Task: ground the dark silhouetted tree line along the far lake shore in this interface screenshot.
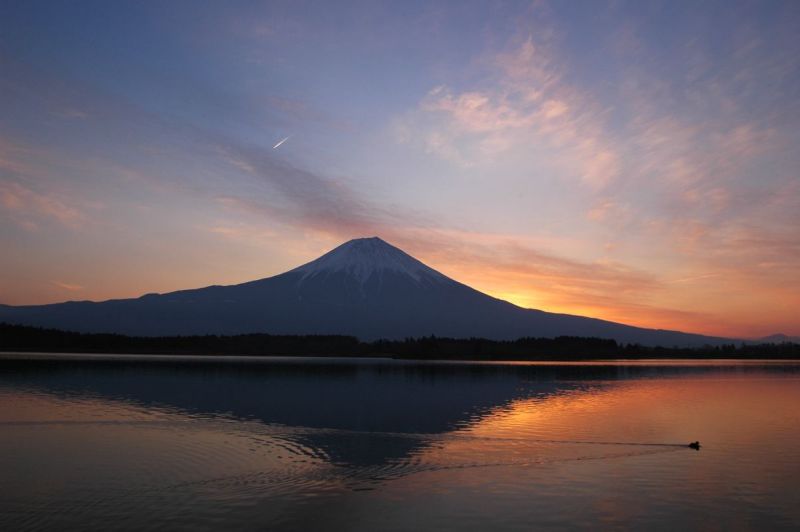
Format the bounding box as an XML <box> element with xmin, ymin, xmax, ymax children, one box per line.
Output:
<box><xmin>0</xmin><ymin>323</ymin><xmax>800</xmax><ymax>360</ymax></box>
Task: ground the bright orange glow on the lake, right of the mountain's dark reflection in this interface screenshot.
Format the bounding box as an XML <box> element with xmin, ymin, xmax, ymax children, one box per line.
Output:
<box><xmin>404</xmin><ymin>377</ymin><xmax>800</xmax><ymax>476</ymax></box>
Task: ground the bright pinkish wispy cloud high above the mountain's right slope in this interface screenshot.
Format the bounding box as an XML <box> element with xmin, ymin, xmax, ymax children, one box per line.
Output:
<box><xmin>402</xmin><ymin>32</ymin><xmax>621</xmax><ymax>189</ymax></box>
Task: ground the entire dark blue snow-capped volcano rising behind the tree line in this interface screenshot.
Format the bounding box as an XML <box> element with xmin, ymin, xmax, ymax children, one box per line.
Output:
<box><xmin>0</xmin><ymin>237</ymin><xmax>731</xmax><ymax>347</ymax></box>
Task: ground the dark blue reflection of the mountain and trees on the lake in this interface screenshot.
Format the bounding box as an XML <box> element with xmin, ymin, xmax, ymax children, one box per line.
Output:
<box><xmin>0</xmin><ymin>357</ymin><xmax>788</xmax><ymax>465</ymax></box>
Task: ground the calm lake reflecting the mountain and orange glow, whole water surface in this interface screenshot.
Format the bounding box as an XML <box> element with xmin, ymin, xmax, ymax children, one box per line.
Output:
<box><xmin>0</xmin><ymin>354</ymin><xmax>800</xmax><ymax>531</ymax></box>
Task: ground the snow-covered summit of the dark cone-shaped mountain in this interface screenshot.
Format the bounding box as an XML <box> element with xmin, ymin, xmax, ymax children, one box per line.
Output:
<box><xmin>292</xmin><ymin>236</ymin><xmax>448</xmax><ymax>284</ymax></box>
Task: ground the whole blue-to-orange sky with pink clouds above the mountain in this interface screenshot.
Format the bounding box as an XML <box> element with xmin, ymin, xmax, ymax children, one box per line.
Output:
<box><xmin>0</xmin><ymin>0</ymin><xmax>800</xmax><ymax>337</ymax></box>
